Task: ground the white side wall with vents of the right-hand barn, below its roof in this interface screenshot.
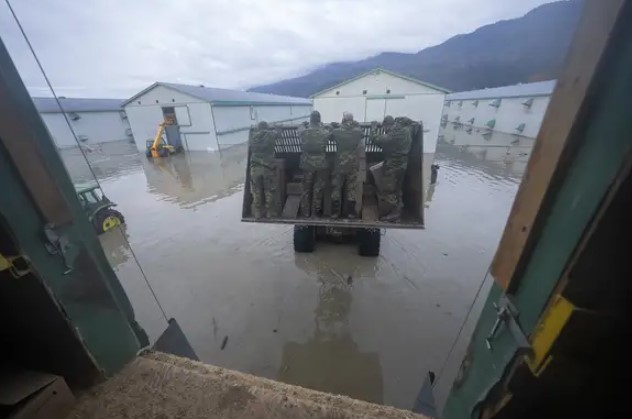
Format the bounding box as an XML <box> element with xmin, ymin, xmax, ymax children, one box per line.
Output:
<box><xmin>444</xmin><ymin>96</ymin><xmax>550</xmax><ymax>137</ymax></box>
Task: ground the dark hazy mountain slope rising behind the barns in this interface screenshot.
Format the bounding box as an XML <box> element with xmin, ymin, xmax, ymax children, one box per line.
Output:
<box><xmin>250</xmin><ymin>0</ymin><xmax>583</xmax><ymax>97</ymax></box>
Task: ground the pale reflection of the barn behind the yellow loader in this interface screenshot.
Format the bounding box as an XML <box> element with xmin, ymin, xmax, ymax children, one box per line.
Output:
<box><xmin>143</xmin><ymin>145</ymin><xmax>247</xmax><ymax>208</ymax></box>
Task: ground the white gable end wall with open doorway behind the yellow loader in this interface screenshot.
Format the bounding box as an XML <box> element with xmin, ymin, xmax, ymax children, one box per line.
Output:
<box><xmin>125</xmin><ymin>86</ymin><xmax>217</xmax><ymax>151</ymax></box>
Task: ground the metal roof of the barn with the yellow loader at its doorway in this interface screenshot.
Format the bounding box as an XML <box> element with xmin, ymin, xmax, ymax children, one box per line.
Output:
<box><xmin>123</xmin><ymin>82</ymin><xmax>312</xmax><ymax>106</ymax></box>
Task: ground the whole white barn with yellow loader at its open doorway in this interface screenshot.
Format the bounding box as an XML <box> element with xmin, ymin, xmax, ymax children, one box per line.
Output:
<box><xmin>123</xmin><ymin>82</ymin><xmax>312</xmax><ymax>151</ymax></box>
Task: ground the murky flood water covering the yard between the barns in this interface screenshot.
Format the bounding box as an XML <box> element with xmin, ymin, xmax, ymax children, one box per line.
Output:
<box><xmin>61</xmin><ymin>127</ymin><xmax>531</xmax><ymax>409</ymax></box>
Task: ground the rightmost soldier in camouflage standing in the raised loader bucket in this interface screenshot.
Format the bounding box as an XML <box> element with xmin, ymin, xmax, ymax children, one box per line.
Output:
<box><xmin>372</xmin><ymin>116</ymin><xmax>412</xmax><ymax>221</ymax></box>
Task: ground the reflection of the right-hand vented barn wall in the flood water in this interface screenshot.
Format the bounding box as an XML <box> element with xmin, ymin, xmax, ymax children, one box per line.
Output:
<box><xmin>439</xmin><ymin>123</ymin><xmax>535</xmax><ymax>176</ymax></box>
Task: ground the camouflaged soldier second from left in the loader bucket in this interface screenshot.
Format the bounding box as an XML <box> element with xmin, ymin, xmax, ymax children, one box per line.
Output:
<box><xmin>299</xmin><ymin>111</ymin><xmax>330</xmax><ymax>217</ymax></box>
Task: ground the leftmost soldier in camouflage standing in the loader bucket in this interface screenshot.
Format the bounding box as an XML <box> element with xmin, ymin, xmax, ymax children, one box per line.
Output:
<box><xmin>250</xmin><ymin>121</ymin><xmax>279</xmax><ymax>218</ymax></box>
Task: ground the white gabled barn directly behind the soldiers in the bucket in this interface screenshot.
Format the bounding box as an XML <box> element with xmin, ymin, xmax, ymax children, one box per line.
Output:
<box><xmin>312</xmin><ymin>68</ymin><xmax>448</xmax><ymax>153</ymax></box>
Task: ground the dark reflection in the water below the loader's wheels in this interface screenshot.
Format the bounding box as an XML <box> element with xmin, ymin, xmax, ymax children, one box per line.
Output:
<box><xmin>278</xmin><ymin>254</ymin><xmax>383</xmax><ymax>403</ymax></box>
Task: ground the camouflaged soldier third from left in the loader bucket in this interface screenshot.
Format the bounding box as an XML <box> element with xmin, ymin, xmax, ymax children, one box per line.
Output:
<box><xmin>331</xmin><ymin>112</ymin><xmax>362</xmax><ymax>218</ymax></box>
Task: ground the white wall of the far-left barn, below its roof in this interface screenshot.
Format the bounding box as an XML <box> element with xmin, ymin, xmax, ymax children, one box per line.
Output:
<box><xmin>41</xmin><ymin>110</ymin><xmax>131</xmax><ymax>148</ymax></box>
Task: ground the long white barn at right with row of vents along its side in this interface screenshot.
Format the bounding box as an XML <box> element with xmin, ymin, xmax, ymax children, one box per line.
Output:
<box><xmin>442</xmin><ymin>80</ymin><xmax>556</xmax><ymax>138</ymax></box>
